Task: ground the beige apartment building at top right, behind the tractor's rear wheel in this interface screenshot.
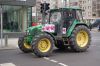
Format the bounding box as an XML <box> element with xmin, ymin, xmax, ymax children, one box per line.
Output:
<box><xmin>79</xmin><ymin>0</ymin><xmax>100</xmax><ymax>22</ymax></box>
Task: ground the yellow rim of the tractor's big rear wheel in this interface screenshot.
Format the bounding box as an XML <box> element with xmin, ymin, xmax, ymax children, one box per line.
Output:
<box><xmin>76</xmin><ymin>30</ymin><xmax>89</xmax><ymax>47</ymax></box>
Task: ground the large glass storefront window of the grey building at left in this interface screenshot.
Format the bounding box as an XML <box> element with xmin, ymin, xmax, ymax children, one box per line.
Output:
<box><xmin>2</xmin><ymin>5</ymin><xmax>32</xmax><ymax>32</ymax></box>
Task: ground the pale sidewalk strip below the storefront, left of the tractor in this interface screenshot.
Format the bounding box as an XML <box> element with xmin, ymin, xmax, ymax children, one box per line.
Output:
<box><xmin>0</xmin><ymin>38</ymin><xmax>18</xmax><ymax>50</ymax></box>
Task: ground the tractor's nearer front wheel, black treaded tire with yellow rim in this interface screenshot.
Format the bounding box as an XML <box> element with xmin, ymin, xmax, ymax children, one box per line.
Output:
<box><xmin>32</xmin><ymin>33</ymin><xmax>54</xmax><ymax>57</ymax></box>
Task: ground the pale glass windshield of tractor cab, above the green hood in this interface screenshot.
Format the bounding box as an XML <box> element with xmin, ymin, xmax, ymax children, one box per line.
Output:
<box><xmin>49</xmin><ymin>12</ymin><xmax>61</xmax><ymax>24</ymax></box>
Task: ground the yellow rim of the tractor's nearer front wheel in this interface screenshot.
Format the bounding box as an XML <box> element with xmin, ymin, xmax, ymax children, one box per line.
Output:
<box><xmin>38</xmin><ymin>38</ymin><xmax>51</xmax><ymax>52</ymax></box>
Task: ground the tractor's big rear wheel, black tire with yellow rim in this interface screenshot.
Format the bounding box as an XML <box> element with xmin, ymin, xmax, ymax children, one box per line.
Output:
<box><xmin>70</xmin><ymin>25</ymin><xmax>91</xmax><ymax>52</ymax></box>
